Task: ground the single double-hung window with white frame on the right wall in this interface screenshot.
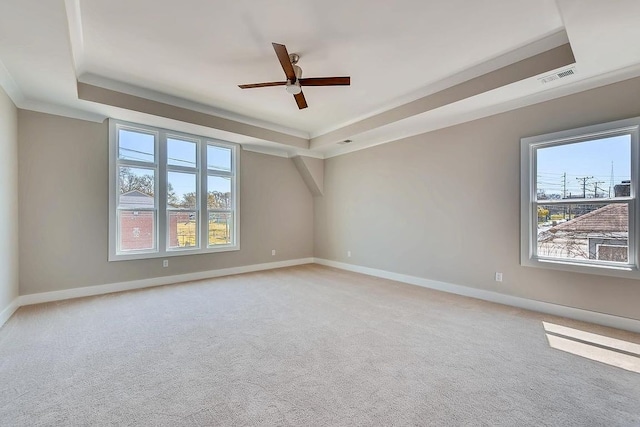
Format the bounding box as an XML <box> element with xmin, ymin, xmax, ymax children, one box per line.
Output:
<box><xmin>521</xmin><ymin>118</ymin><xmax>640</xmax><ymax>278</ymax></box>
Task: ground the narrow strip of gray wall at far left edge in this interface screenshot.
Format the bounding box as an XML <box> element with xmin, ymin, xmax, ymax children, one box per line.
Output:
<box><xmin>0</xmin><ymin>87</ymin><xmax>19</xmax><ymax>313</ymax></box>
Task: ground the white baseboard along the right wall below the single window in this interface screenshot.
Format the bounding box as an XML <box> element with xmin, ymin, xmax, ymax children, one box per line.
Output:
<box><xmin>314</xmin><ymin>258</ymin><xmax>640</xmax><ymax>333</ymax></box>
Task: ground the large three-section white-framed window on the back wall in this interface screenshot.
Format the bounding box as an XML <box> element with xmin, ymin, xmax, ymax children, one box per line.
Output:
<box><xmin>109</xmin><ymin>120</ymin><xmax>239</xmax><ymax>261</ymax></box>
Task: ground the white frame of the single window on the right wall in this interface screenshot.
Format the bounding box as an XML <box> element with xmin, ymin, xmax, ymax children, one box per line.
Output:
<box><xmin>520</xmin><ymin>117</ymin><xmax>640</xmax><ymax>279</ymax></box>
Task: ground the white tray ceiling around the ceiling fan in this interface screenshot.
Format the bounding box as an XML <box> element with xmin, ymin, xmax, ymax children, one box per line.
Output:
<box><xmin>0</xmin><ymin>0</ymin><xmax>640</xmax><ymax>157</ymax></box>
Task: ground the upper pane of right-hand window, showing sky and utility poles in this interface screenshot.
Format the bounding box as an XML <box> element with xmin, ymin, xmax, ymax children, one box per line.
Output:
<box><xmin>536</xmin><ymin>135</ymin><xmax>631</xmax><ymax>200</ymax></box>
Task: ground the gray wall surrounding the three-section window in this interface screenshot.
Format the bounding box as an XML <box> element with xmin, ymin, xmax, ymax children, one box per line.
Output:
<box><xmin>20</xmin><ymin>110</ymin><xmax>313</xmax><ymax>295</ymax></box>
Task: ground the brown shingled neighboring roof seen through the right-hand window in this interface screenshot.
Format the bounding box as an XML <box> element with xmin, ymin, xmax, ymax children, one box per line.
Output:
<box><xmin>548</xmin><ymin>203</ymin><xmax>629</xmax><ymax>233</ymax></box>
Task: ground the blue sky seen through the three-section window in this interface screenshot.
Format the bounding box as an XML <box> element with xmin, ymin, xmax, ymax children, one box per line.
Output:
<box><xmin>119</xmin><ymin>129</ymin><xmax>231</xmax><ymax>198</ymax></box>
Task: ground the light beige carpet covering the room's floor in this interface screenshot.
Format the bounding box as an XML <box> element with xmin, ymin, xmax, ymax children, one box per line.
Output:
<box><xmin>0</xmin><ymin>265</ymin><xmax>640</xmax><ymax>427</ymax></box>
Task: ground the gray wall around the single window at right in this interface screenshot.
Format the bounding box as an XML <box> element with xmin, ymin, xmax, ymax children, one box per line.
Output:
<box><xmin>314</xmin><ymin>79</ymin><xmax>640</xmax><ymax>319</ymax></box>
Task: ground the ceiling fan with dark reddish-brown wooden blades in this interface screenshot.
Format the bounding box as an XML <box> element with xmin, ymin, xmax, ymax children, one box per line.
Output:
<box><xmin>238</xmin><ymin>43</ymin><xmax>351</xmax><ymax>110</ymax></box>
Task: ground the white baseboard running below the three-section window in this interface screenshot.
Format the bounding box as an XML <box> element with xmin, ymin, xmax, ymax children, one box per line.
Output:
<box><xmin>17</xmin><ymin>258</ymin><xmax>313</xmax><ymax>313</ymax></box>
